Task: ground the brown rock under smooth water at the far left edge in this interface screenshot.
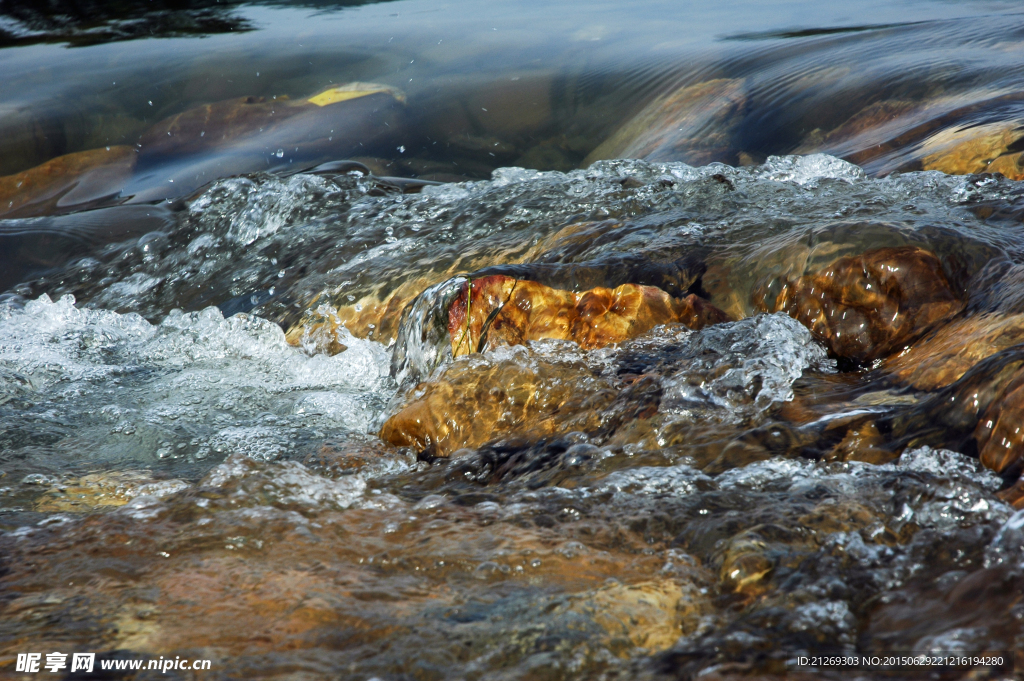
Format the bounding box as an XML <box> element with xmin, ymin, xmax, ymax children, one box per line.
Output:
<box><xmin>0</xmin><ymin>146</ymin><xmax>136</xmax><ymax>217</ymax></box>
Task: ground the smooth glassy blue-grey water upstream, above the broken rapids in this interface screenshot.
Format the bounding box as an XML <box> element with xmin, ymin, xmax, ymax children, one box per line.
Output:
<box><xmin>0</xmin><ymin>1</ymin><xmax>1021</xmax><ymax>201</ymax></box>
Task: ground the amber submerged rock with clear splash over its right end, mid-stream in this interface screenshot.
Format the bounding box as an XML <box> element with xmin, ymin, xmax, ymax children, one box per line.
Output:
<box><xmin>381</xmin><ymin>314</ymin><xmax>831</xmax><ymax>456</ymax></box>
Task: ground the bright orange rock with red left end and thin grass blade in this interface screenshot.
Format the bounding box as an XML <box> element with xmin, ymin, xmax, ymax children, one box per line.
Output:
<box><xmin>449</xmin><ymin>274</ymin><xmax>728</xmax><ymax>356</ymax></box>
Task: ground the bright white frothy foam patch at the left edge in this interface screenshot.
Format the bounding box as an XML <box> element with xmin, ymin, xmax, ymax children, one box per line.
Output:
<box><xmin>0</xmin><ymin>296</ymin><xmax>393</xmax><ymax>460</ymax></box>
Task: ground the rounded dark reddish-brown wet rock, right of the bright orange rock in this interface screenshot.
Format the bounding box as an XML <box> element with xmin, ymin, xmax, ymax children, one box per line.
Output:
<box><xmin>753</xmin><ymin>247</ymin><xmax>964</xmax><ymax>361</ymax></box>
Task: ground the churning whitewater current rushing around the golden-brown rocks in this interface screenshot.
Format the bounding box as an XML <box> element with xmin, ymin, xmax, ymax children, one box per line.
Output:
<box><xmin>0</xmin><ymin>156</ymin><xmax>1024</xmax><ymax>679</ymax></box>
